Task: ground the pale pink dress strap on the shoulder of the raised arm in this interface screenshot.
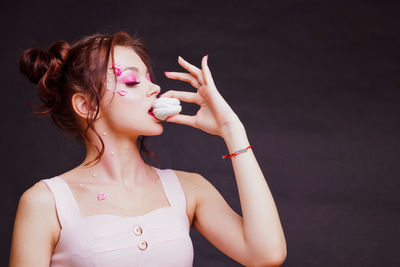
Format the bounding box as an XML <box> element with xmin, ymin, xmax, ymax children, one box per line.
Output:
<box><xmin>154</xmin><ymin>167</ymin><xmax>186</xmax><ymax>214</ymax></box>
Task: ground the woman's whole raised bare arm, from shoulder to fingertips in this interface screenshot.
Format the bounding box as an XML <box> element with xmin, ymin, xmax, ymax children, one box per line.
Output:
<box><xmin>163</xmin><ymin>56</ymin><xmax>286</xmax><ymax>266</ymax></box>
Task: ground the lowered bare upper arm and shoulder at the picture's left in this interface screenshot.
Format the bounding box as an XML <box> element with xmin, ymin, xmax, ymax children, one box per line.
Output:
<box><xmin>10</xmin><ymin>182</ymin><xmax>59</xmax><ymax>267</ymax></box>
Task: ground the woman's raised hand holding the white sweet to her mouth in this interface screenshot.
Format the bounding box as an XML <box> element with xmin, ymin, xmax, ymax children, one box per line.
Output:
<box><xmin>162</xmin><ymin>56</ymin><xmax>241</xmax><ymax>137</ymax></box>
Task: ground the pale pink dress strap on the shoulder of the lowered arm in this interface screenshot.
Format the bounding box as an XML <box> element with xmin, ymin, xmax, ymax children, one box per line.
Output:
<box><xmin>41</xmin><ymin>176</ymin><xmax>80</xmax><ymax>228</ymax></box>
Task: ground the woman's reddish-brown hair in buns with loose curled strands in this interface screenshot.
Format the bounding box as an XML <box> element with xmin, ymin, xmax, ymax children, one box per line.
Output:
<box><xmin>19</xmin><ymin>32</ymin><xmax>160</xmax><ymax>167</ymax></box>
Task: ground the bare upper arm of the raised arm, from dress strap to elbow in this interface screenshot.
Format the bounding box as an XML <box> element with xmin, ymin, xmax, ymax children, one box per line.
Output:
<box><xmin>192</xmin><ymin>173</ymin><xmax>249</xmax><ymax>265</ymax></box>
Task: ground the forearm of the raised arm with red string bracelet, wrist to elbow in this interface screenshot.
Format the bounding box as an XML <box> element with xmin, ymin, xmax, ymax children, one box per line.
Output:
<box><xmin>222</xmin><ymin>122</ymin><xmax>286</xmax><ymax>262</ymax></box>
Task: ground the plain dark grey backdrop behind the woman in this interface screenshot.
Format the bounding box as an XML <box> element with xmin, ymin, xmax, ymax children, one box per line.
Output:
<box><xmin>0</xmin><ymin>0</ymin><xmax>400</xmax><ymax>266</ymax></box>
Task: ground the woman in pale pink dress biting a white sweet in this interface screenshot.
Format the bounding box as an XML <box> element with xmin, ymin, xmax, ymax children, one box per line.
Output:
<box><xmin>10</xmin><ymin>32</ymin><xmax>286</xmax><ymax>267</ymax></box>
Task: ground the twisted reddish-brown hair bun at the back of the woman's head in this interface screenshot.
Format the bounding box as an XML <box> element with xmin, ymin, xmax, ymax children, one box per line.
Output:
<box><xmin>19</xmin><ymin>41</ymin><xmax>70</xmax><ymax>84</ymax></box>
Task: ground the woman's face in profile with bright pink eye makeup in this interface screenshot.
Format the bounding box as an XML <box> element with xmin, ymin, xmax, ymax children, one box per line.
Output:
<box><xmin>100</xmin><ymin>46</ymin><xmax>163</xmax><ymax>137</ymax></box>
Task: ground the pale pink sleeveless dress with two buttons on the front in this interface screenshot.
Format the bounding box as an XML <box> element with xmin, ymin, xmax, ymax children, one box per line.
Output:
<box><xmin>41</xmin><ymin>168</ymin><xmax>194</xmax><ymax>267</ymax></box>
